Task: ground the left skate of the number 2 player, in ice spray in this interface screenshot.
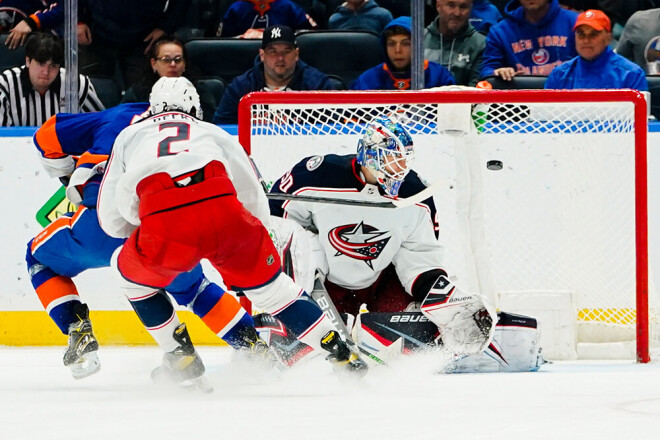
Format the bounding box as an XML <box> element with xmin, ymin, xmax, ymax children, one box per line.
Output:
<box><xmin>151</xmin><ymin>323</ymin><xmax>213</xmax><ymax>393</ymax></box>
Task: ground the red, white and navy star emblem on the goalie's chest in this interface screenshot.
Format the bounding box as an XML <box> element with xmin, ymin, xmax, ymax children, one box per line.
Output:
<box><xmin>328</xmin><ymin>222</ymin><xmax>391</xmax><ymax>269</ymax></box>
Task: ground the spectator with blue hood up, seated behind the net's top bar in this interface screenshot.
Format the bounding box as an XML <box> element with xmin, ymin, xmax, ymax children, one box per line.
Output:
<box><xmin>351</xmin><ymin>16</ymin><xmax>455</xmax><ymax>90</ymax></box>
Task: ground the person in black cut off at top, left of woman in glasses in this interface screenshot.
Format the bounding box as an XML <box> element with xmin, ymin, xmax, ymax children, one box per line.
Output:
<box><xmin>78</xmin><ymin>0</ymin><xmax>189</xmax><ymax>89</ymax></box>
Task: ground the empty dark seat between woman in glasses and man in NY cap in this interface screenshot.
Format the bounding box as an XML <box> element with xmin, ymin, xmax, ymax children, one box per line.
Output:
<box><xmin>186</xmin><ymin>38</ymin><xmax>261</xmax><ymax>84</ymax></box>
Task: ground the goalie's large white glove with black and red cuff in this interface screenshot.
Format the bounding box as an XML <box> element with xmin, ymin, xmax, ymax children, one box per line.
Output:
<box><xmin>413</xmin><ymin>270</ymin><xmax>497</xmax><ymax>355</ymax></box>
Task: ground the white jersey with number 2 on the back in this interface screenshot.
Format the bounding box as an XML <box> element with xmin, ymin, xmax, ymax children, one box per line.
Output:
<box><xmin>98</xmin><ymin>112</ymin><xmax>270</xmax><ymax>238</ymax></box>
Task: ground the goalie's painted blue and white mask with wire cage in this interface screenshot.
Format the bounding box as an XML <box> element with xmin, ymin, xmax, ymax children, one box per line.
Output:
<box><xmin>357</xmin><ymin>117</ymin><xmax>415</xmax><ymax>197</ymax></box>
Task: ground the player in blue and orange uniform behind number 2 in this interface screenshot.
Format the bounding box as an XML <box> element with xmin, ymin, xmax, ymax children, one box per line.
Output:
<box><xmin>26</xmin><ymin>103</ymin><xmax>274</xmax><ymax>381</ymax></box>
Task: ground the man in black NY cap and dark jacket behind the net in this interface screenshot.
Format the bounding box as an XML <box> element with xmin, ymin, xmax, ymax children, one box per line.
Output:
<box><xmin>213</xmin><ymin>25</ymin><xmax>337</xmax><ymax>124</ymax></box>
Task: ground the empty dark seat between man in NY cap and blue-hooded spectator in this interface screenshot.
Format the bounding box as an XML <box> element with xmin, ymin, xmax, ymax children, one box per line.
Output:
<box><xmin>296</xmin><ymin>30</ymin><xmax>384</xmax><ymax>87</ymax></box>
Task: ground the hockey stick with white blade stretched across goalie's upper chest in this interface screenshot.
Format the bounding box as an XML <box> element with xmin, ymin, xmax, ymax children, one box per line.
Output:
<box><xmin>246</xmin><ymin>153</ymin><xmax>443</xmax><ymax>208</ymax></box>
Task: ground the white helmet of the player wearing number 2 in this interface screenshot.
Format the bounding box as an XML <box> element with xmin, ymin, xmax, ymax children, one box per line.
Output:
<box><xmin>149</xmin><ymin>76</ymin><xmax>202</xmax><ymax>119</ymax></box>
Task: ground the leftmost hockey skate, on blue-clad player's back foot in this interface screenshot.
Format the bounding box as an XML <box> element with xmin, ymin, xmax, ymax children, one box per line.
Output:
<box><xmin>64</xmin><ymin>304</ymin><xmax>101</xmax><ymax>379</ymax></box>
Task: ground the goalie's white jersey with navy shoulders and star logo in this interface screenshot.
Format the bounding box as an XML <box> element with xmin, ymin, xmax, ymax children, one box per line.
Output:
<box><xmin>269</xmin><ymin>154</ymin><xmax>443</xmax><ymax>293</ymax></box>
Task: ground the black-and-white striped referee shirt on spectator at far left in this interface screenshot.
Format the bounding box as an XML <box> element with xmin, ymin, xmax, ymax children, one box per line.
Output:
<box><xmin>0</xmin><ymin>66</ymin><xmax>103</xmax><ymax>127</ymax></box>
